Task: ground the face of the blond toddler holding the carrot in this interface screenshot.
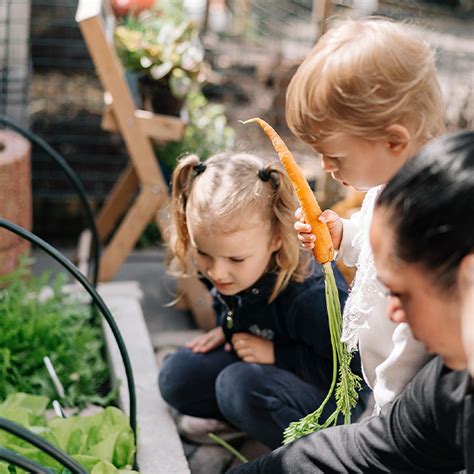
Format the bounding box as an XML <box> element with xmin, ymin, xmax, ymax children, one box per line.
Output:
<box><xmin>317</xmin><ymin>133</ymin><xmax>408</xmax><ymax>191</ymax></box>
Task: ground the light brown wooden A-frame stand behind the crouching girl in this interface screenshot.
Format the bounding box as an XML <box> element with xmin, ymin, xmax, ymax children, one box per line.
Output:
<box><xmin>76</xmin><ymin>0</ymin><xmax>215</xmax><ymax>329</ymax></box>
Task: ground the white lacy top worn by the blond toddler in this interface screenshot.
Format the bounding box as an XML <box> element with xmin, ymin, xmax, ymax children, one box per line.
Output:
<box><xmin>338</xmin><ymin>186</ymin><xmax>432</xmax><ymax>412</ymax></box>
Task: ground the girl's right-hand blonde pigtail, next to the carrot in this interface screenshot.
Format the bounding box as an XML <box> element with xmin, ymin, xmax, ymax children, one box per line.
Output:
<box><xmin>259</xmin><ymin>164</ymin><xmax>310</xmax><ymax>302</ymax></box>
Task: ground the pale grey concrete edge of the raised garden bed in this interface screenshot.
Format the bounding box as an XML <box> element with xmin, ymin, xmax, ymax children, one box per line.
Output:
<box><xmin>100</xmin><ymin>282</ymin><xmax>190</xmax><ymax>474</ymax></box>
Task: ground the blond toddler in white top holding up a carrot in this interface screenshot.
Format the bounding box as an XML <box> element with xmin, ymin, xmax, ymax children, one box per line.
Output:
<box><xmin>286</xmin><ymin>18</ymin><xmax>444</xmax><ymax>410</ymax></box>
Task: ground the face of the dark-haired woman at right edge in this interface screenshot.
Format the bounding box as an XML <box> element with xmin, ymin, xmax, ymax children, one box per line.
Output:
<box><xmin>370</xmin><ymin>209</ymin><xmax>467</xmax><ymax>370</ymax></box>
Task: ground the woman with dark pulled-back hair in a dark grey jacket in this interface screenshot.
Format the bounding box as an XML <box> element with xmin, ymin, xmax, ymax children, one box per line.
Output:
<box><xmin>232</xmin><ymin>132</ymin><xmax>474</xmax><ymax>474</ymax></box>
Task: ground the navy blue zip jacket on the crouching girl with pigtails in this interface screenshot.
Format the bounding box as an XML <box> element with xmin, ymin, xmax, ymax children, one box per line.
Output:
<box><xmin>201</xmin><ymin>263</ymin><xmax>361</xmax><ymax>389</ymax></box>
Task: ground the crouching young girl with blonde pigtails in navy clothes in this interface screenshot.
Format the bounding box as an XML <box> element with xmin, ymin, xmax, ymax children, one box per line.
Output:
<box><xmin>159</xmin><ymin>153</ymin><xmax>367</xmax><ymax>449</ymax></box>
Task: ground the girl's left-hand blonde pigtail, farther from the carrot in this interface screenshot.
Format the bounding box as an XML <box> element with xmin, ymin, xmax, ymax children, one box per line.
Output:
<box><xmin>167</xmin><ymin>155</ymin><xmax>200</xmax><ymax>276</ymax></box>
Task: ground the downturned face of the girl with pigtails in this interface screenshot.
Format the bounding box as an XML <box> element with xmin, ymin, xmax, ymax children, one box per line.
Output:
<box><xmin>188</xmin><ymin>215</ymin><xmax>281</xmax><ymax>295</ymax></box>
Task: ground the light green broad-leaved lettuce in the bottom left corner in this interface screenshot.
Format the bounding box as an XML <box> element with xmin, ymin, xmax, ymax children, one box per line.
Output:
<box><xmin>0</xmin><ymin>393</ymin><xmax>136</xmax><ymax>474</ymax></box>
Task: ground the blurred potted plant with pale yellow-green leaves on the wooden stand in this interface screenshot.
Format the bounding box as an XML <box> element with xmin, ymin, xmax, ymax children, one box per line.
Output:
<box><xmin>114</xmin><ymin>2</ymin><xmax>205</xmax><ymax>116</ymax></box>
